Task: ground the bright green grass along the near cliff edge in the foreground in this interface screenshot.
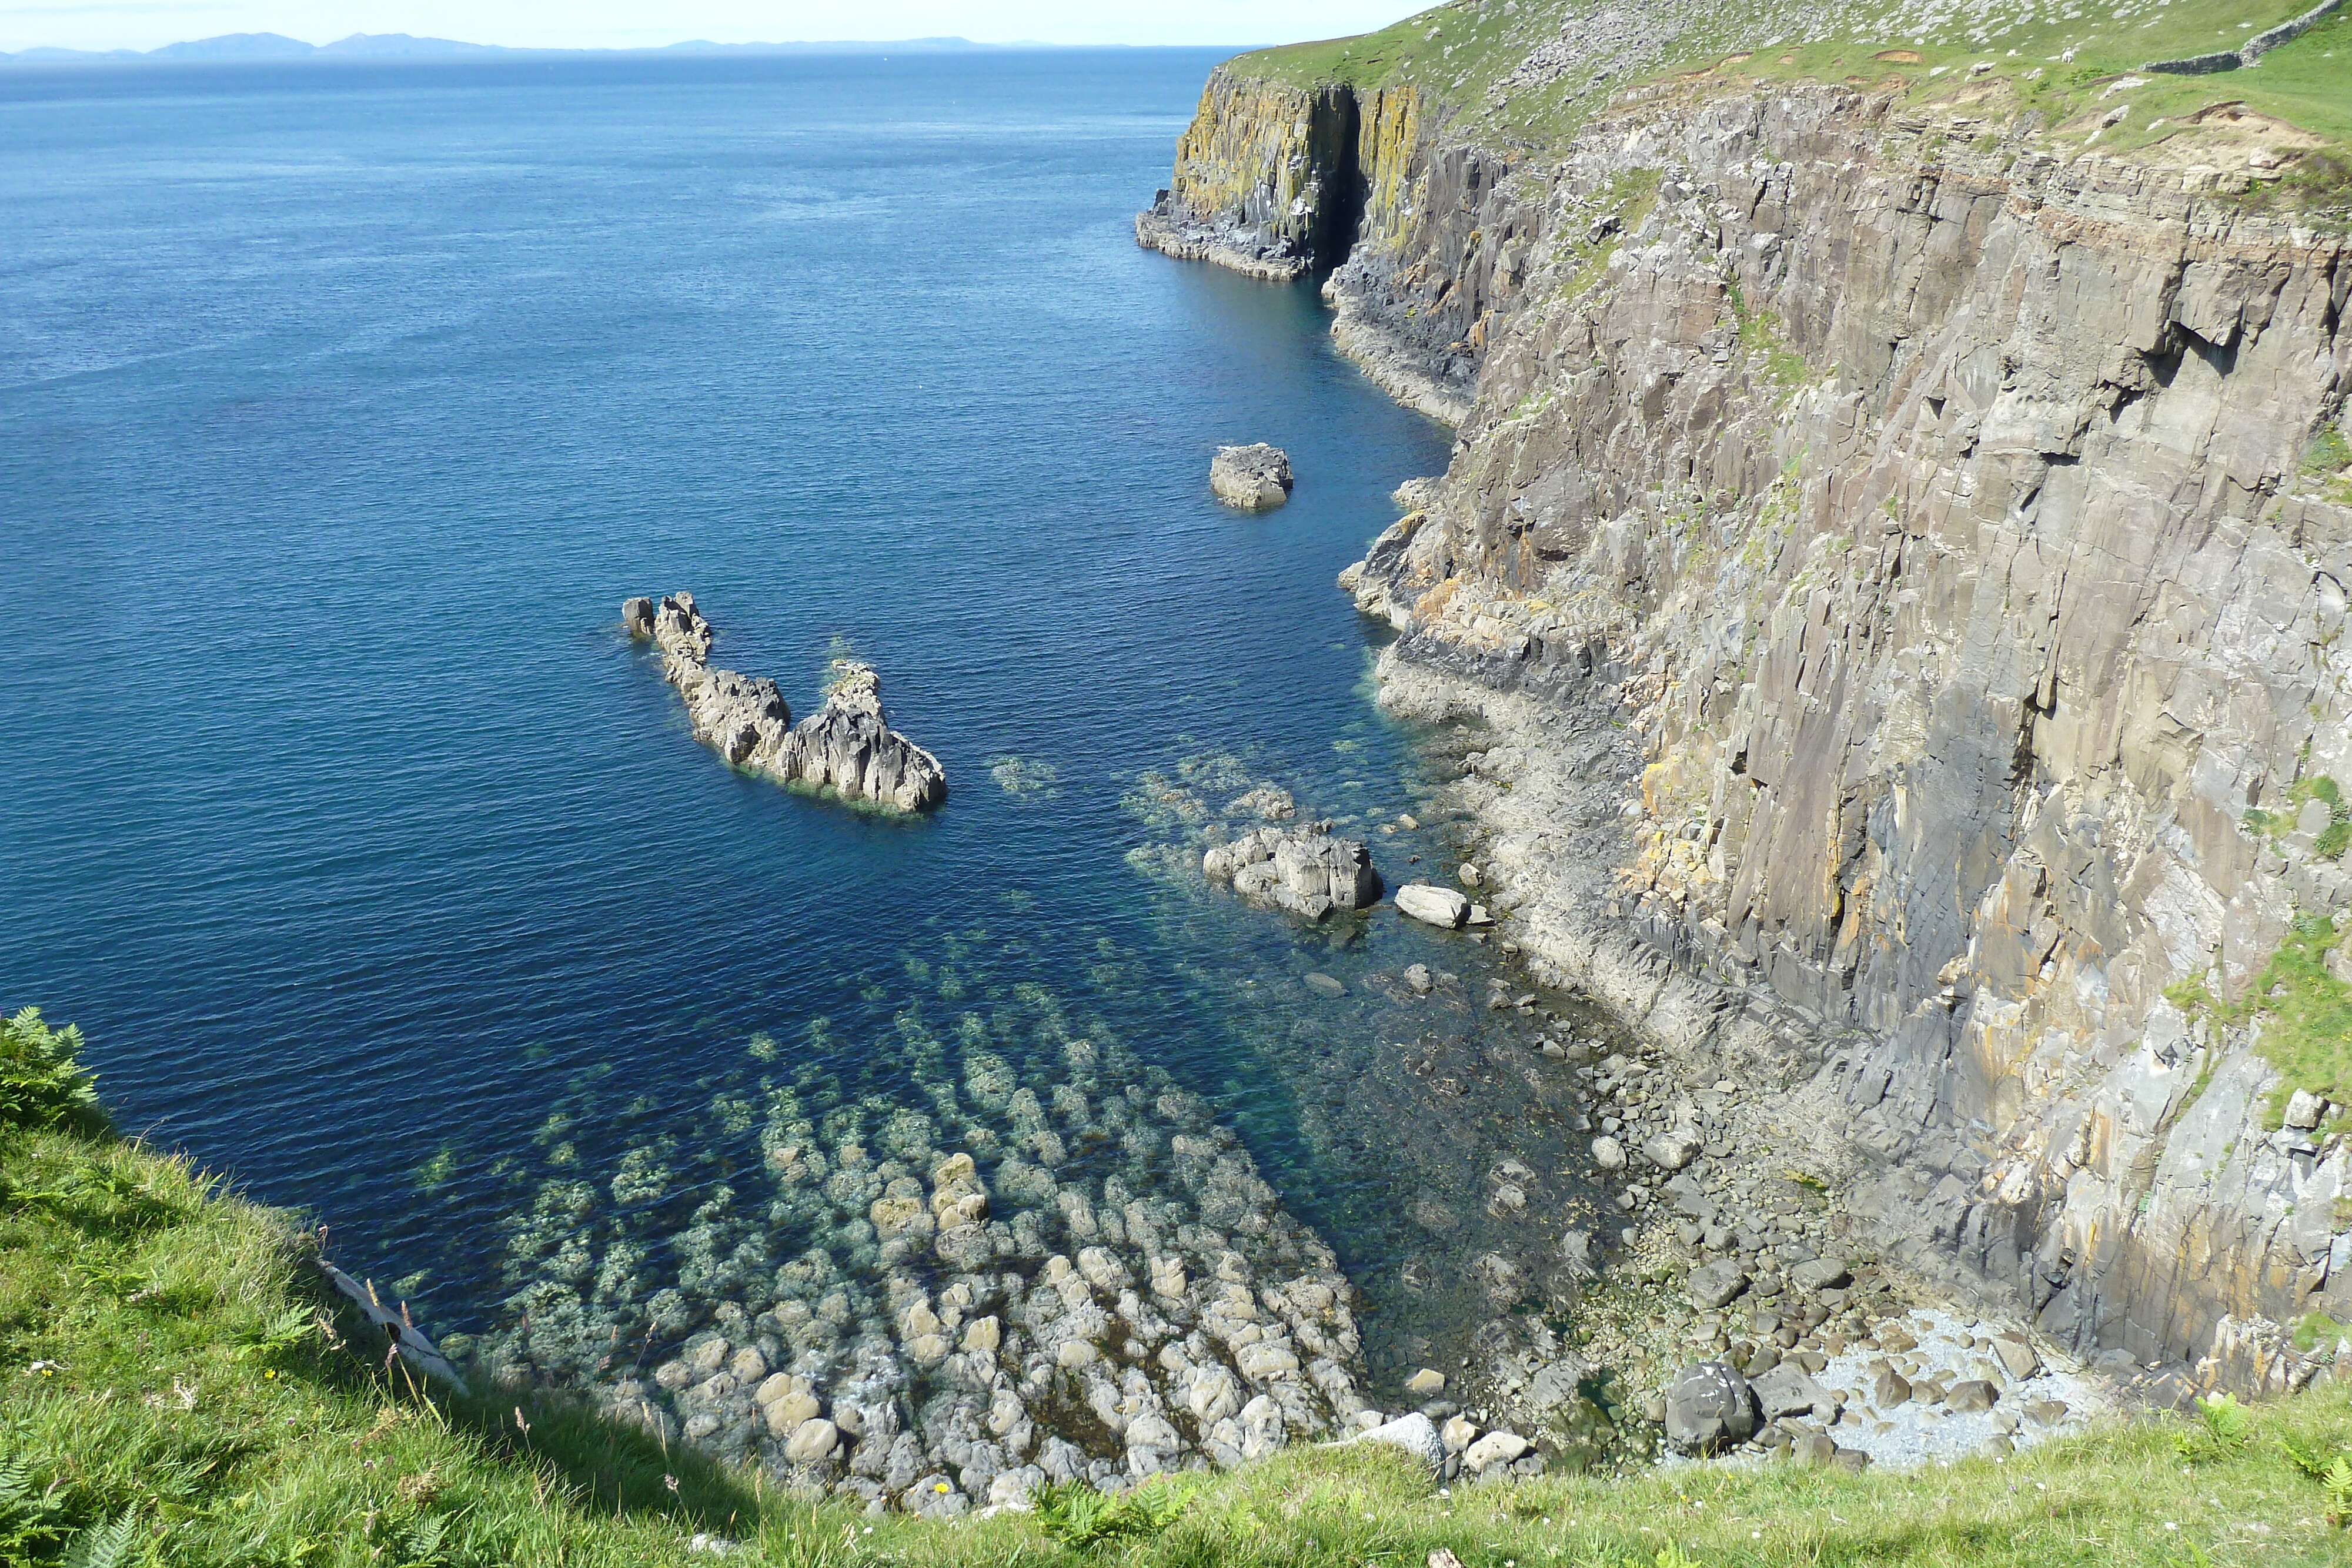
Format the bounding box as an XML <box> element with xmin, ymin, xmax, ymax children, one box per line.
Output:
<box><xmin>14</xmin><ymin>1013</ymin><xmax>2352</xmax><ymax>1568</ymax></box>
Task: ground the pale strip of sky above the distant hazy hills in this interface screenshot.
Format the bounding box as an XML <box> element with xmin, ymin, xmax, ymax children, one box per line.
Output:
<box><xmin>0</xmin><ymin>0</ymin><xmax>1430</xmax><ymax>49</ymax></box>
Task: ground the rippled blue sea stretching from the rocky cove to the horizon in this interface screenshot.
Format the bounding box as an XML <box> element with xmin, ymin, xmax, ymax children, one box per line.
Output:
<box><xmin>0</xmin><ymin>49</ymin><xmax>1599</xmax><ymax>1392</ymax></box>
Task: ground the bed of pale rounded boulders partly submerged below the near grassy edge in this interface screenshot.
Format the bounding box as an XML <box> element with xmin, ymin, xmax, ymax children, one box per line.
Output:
<box><xmin>489</xmin><ymin>992</ymin><xmax>1378</xmax><ymax>1514</ymax></box>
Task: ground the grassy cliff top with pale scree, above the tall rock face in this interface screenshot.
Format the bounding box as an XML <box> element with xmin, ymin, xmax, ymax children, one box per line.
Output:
<box><xmin>1228</xmin><ymin>0</ymin><xmax>2352</xmax><ymax>202</ymax></box>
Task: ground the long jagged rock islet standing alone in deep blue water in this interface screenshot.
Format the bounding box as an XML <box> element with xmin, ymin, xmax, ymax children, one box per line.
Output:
<box><xmin>621</xmin><ymin>593</ymin><xmax>948</xmax><ymax>811</ymax></box>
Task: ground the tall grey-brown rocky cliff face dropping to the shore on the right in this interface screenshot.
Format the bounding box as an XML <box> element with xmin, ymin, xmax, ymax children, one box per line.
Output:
<box><xmin>1152</xmin><ymin>55</ymin><xmax>2352</xmax><ymax>1385</ymax></box>
